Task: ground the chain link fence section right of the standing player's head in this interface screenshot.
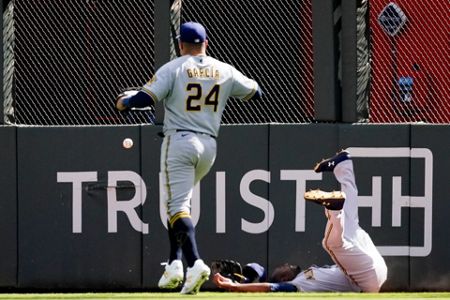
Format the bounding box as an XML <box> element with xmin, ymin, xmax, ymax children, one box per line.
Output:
<box><xmin>181</xmin><ymin>0</ymin><xmax>314</xmax><ymax>124</ymax></box>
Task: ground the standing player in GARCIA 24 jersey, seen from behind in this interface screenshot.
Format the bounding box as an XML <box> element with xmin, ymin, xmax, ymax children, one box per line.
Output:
<box><xmin>116</xmin><ymin>22</ymin><xmax>262</xmax><ymax>294</ymax></box>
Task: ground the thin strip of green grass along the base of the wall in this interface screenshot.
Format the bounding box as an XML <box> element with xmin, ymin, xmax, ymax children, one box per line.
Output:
<box><xmin>0</xmin><ymin>292</ymin><xmax>450</xmax><ymax>300</ymax></box>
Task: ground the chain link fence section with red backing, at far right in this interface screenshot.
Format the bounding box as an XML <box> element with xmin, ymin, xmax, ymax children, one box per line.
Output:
<box><xmin>370</xmin><ymin>0</ymin><xmax>450</xmax><ymax>123</ymax></box>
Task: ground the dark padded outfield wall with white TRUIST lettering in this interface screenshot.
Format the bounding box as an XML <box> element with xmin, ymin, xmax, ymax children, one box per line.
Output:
<box><xmin>0</xmin><ymin>124</ymin><xmax>450</xmax><ymax>291</ymax></box>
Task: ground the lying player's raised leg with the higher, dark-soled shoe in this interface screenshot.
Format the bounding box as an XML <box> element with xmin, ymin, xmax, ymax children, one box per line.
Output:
<box><xmin>315</xmin><ymin>151</ymin><xmax>386</xmax><ymax>292</ymax></box>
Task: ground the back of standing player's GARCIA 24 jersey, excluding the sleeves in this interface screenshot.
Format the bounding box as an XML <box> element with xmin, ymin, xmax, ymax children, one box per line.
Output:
<box><xmin>164</xmin><ymin>56</ymin><xmax>237</xmax><ymax>136</ymax></box>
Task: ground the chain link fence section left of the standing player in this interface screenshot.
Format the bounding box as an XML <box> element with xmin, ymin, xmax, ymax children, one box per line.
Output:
<box><xmin>3</xmin><ymin>0</ymin><xmax>154</xmax><ymax>125</ymax></box>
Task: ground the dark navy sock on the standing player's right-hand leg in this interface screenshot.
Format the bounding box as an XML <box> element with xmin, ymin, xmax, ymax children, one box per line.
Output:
<box><xmin>171</xmin><ymin>213</ymin><xmax>200</xmax><ymax>268</ymax></box>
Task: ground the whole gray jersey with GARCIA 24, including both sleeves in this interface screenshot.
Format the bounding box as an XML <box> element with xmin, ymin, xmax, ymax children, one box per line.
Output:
<box><xmin>143</xmin><ymin>55</ymin><xmax>258</xmax><ymax>136</ymax></box>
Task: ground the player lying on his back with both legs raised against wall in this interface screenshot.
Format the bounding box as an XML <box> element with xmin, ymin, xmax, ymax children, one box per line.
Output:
<box><xmin>214</xmin><ymin>151</ymin><xmax>387</xmax><ymax>293</ymax></box>
